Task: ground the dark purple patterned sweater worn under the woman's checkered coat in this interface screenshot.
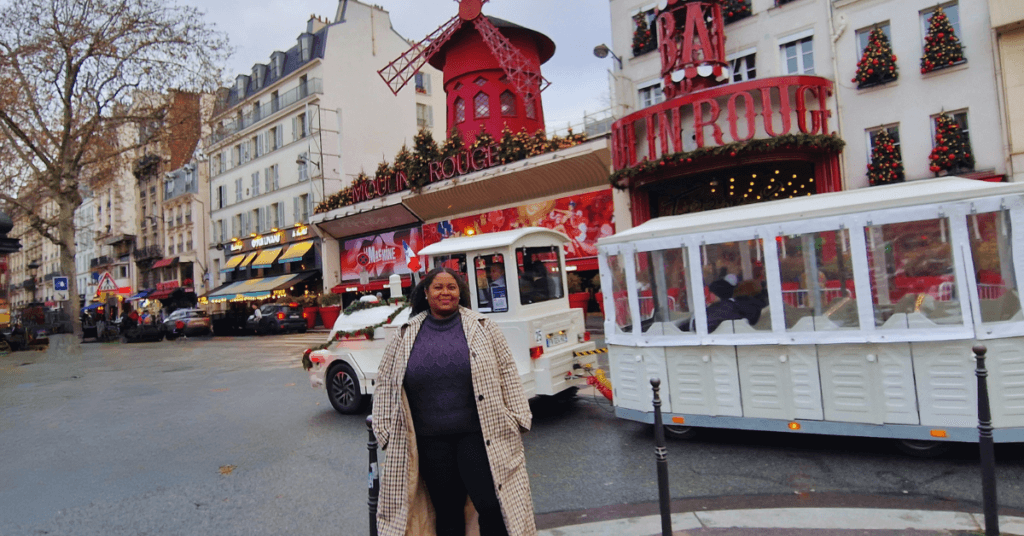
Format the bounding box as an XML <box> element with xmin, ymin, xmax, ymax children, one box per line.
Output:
<box><xmin>404</xmin><ymin>313</ymin><xmax>480</xmax><ymax>436</ymax></box>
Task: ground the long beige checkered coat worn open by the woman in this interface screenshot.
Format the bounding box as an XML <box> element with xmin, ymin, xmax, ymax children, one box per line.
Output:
<box><xmin>373</xmin><ymin>307</ymin><xmax>537</xmax><ymax>536</ymax></box>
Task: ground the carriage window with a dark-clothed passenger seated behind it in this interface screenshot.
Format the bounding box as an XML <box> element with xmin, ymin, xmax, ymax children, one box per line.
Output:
<box><xmin>700</xmin><ymin>239</ymin><xmax>771</xmax><ymax>333</ymax></box>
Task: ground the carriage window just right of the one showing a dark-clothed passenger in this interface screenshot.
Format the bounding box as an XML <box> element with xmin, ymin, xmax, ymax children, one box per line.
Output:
<box><xmin>778</xmin><ymin>230</ymin><xmax>860</xmax><ymax>331</ymax></box>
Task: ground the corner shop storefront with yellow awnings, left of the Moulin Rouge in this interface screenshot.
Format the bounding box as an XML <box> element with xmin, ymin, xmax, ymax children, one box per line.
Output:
<box><xmin>200</xmin><ymin>225</ymin><xmax>324</xmax><ymax>304</ymax></box>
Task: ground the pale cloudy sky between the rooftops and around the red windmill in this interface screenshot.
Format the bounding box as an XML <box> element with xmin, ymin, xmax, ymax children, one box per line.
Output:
<box><xmin>192</xmin><ymin>0</ymin><xmax>613</xmax><ymax>128</ymax></box>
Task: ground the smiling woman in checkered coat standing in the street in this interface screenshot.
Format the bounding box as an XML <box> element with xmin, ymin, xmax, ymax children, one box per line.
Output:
<box><xmin>373</xmin><ymin>267</ymin><xmax>537</xmax><ymax>536</ymax></box>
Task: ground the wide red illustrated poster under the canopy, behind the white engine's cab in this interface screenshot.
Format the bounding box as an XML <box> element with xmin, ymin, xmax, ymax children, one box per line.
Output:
<box><xmin>422</xmin><ymin>189</ymin><xmax>615</xmax><ymax>259</ymax></box>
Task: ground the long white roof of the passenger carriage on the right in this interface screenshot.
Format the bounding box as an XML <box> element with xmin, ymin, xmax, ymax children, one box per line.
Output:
<box><xmin>598</xmin><ymin>177</ymin><xmax>1024</xmax><ymax>246</ymax></box>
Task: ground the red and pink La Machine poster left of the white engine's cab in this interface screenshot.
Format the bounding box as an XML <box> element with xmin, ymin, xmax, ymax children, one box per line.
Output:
<box><xmin>341</xmin><ymin>228</ymin><xmax>424</xmax><ymax>284</ymax></box>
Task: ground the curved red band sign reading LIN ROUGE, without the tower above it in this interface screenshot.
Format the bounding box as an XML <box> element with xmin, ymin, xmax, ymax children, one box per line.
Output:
<box><xmin>611</xmin><ymin>76</ymin><xmax>833</xmax><ymax>170</ymax></box>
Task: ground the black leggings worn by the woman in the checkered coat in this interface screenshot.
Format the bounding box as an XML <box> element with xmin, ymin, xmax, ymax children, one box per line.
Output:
<box><xmin>416</xmin><ymin>432</ymin><xmax>508</xmax><ymax>536</ymax></box>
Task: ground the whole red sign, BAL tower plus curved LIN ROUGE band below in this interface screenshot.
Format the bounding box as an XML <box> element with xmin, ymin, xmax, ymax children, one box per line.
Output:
<box><xmin>611</xmin><ymin>0</ymin><xmax>833</xmax><ymax>170</ymax></box>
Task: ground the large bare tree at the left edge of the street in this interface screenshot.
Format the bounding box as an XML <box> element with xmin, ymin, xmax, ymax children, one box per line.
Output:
<box><xmin>0</xmin><ymin>0</ymin><xmax>229</xmax><ymax>335</ymax></box>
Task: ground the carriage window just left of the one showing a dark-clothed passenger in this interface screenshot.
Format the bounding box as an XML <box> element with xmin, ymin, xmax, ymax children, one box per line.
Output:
<box><xmin>636</xmin><ymin>248</ymin><xmax>693</xmax><ymax>334</ymax></box>
